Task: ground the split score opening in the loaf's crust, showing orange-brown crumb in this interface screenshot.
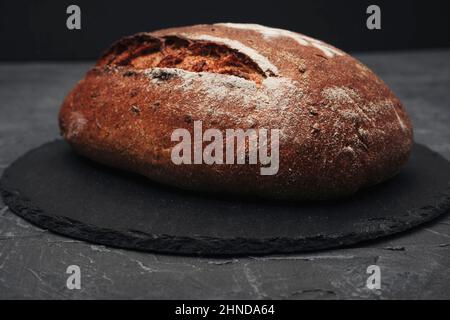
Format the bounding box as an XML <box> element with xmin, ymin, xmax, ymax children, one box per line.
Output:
<box><xmin>97</xmin><ymin>34</ymin><xmax>278</xmax><ymax>83</ymax></box>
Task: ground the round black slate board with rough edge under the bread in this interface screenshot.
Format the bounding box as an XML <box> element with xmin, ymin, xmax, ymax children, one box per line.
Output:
<box><xmin>0</xmin><ymin>141</ymin><xmax>450</xmax><ymax>256</ymax></box>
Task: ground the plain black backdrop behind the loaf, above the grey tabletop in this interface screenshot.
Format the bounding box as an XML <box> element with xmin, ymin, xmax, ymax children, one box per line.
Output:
<box><xmin>0</xmin><ymin>0</ymin><xmax>450</xmax><ymax>60</ymax></box>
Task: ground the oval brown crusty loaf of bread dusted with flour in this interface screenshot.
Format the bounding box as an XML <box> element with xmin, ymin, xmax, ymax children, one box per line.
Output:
<box><xmin>59</xmin><ymin>23</ymin><xmax>412</xmax><ymax>200</ymax></box>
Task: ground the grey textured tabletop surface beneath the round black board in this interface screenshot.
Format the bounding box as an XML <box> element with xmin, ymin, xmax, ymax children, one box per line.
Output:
<box><xmin>0</xmin><ymin>50</ymin><xmax>450</xmax><ymax>299</ymax></box>
